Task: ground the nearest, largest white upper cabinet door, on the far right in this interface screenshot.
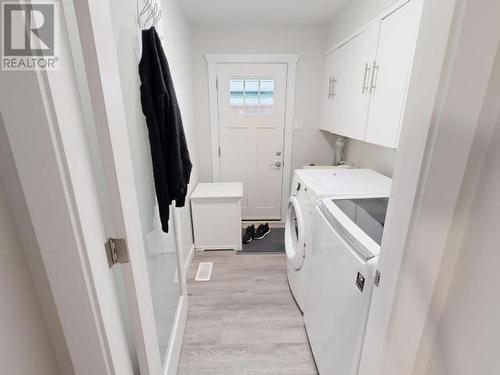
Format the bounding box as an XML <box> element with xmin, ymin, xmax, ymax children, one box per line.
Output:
<box><xmin>366</xmin><ymin>1</ymin><xmax>420</xmax><ymax>148</ymax></box>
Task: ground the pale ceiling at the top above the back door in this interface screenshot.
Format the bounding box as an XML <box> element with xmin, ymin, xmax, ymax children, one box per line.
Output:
<box><xmin>179</xmin><ymin>0</ymin><xmax>349</xmax><ymax>24</ymax></box>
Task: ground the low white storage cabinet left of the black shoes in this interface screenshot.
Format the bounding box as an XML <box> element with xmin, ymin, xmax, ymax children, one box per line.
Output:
<box><xmin>191</xmin><ymin>182</ymin><xmax>243</xmax><ymax>251</ymax></box>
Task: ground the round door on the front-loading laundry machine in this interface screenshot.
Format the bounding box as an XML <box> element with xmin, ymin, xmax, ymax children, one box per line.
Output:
<box><xmin>285</xmin><ymin>197</ymin><xmax>305</xmax><ymax>270</ymax></box>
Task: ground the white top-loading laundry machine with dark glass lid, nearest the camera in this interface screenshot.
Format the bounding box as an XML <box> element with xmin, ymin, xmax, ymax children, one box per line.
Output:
<box><xmin>304</xmin><ymin>195</ymin><xmax>388</xmax><ymax>375</ymax></box>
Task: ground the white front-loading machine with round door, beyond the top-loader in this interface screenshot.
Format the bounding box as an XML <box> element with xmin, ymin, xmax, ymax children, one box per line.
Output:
<box><xmin>285</xmin><ymin>168</ymin><xmax>391</xmax><ymax>311</ymax></box>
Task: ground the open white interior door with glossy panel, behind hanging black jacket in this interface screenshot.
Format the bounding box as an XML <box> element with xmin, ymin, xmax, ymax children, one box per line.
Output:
<box><xmin>65</xmin><ymin>0</ymin><xmax>187</xmax><ymax>375</ymax></box>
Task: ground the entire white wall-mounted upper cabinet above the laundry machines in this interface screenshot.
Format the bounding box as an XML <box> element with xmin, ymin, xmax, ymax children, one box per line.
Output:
<box><xmin>321</xmin><ymin>0</ymin><xmax>420</xmax><ymax>148</ymax></box>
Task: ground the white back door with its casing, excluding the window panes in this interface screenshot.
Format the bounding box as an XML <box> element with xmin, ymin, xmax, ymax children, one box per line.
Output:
<box><xmin>206</xmin><ymin>54</ymin><xmax>298</xmax><ymax>221</ymax></box>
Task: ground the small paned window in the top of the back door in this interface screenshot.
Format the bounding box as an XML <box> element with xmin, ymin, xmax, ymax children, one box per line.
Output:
<box><xmin>229</xmin><ymin>78</ymin><xmax>274</xmax><ymax>113</ymax></box>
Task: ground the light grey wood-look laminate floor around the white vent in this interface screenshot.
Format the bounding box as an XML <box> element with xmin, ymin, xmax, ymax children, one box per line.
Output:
<box><xmin>178</xmin><ymin>251</ymin><xmax>317</xmax><ymax>375</ymax></box>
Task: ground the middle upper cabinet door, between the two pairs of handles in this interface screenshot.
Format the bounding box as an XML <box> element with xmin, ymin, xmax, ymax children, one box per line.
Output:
<box><xmin>332</xmin><ymin>22</ymin><xmax>379</xmax><ymax>140</ymax></box>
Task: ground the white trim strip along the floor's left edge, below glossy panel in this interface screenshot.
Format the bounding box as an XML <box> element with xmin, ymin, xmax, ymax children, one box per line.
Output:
<box><xmin>163</xmin><ymin>295</ymin><xmax>188</xmax><ymax>375</ymax></box>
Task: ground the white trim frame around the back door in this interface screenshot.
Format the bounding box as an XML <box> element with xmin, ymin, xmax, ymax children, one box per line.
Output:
<box><xmin>205</xmin><ymin>53</ymin><xmax>300</xmax><ymax>223</ymax></box>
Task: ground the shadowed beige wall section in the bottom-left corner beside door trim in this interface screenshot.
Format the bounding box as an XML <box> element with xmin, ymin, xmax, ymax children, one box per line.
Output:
<box><xmin>0</xmin><ymin>180</ymin><xmax>60</xmax><ymax>375</ymax></box>
